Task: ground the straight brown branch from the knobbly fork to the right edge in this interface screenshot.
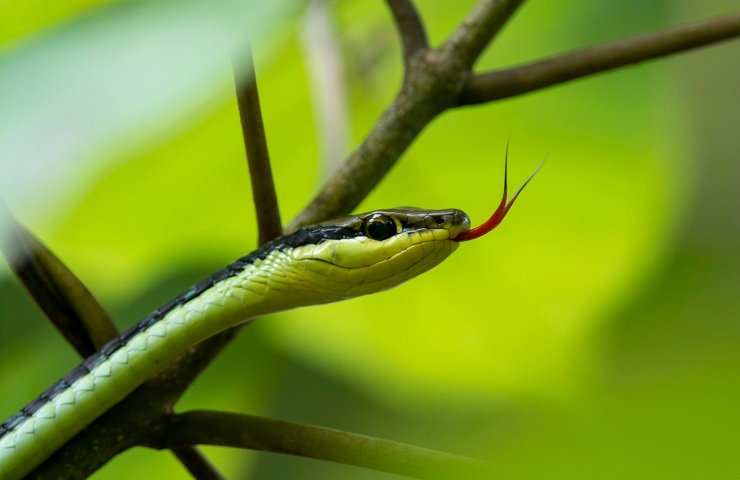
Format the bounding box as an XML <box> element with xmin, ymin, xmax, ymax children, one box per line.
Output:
<box><xmin>460</xmin><ymin>14</ymin><xmax>740</xmax><ymax>105</ymax></box>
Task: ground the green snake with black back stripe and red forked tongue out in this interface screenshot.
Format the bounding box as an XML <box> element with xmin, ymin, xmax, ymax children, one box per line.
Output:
<box><xmin>0</xmin><ymin>160</ymin><xmax>537</xmax><ymax>480</ymax></box>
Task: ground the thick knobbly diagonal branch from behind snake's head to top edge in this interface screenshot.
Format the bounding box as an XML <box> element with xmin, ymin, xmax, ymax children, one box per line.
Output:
<box><xmin>286</xmin><ymin>0</ymin><xmax>523</xmax><ymax>232</ymax></box>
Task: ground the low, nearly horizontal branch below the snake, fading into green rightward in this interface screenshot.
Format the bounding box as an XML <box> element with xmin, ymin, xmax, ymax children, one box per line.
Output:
<box><xmin>158</xmin><ymin>411</ymin><xmax>489</xmax><ymax>478</ymax></box>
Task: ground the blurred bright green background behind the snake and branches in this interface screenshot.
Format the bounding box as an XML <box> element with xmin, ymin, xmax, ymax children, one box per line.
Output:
<box><xmin>0</xmin><ymin>0</ymin><xmax>740</xmax><ymax>479</ymax></box>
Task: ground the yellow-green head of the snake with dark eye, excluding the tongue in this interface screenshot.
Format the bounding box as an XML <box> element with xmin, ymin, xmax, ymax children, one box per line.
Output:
<box><xmin>290</xmin><ymin>207</ymin><xmax>470</xmax><ymax>303</ymax></box>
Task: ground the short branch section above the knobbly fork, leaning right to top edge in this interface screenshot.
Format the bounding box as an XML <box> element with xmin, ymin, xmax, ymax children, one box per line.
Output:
<box><xmin>440</xmin><ymin>0</ymin><xmax>524</xmax><ymax>68</ymax></box>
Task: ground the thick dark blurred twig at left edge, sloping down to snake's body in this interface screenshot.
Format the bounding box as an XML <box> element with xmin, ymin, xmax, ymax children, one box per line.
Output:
<box><xmin>0</xmin><ymin>201</ymin><xmax>118</xmax><ymax>358</ymax></box>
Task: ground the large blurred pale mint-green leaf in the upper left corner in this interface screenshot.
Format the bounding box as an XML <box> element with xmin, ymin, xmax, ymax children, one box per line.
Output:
<box><xmin>0</xmin><ymin>0</ymin><xmax>292</xmax><ymax>232</ymax></box>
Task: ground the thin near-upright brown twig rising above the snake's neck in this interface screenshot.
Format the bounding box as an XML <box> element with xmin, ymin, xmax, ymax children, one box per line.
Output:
<box><xmin>234</xmin><ymin>48</ymin><xmax>283</xmax><ymax>245</ymax></box>
